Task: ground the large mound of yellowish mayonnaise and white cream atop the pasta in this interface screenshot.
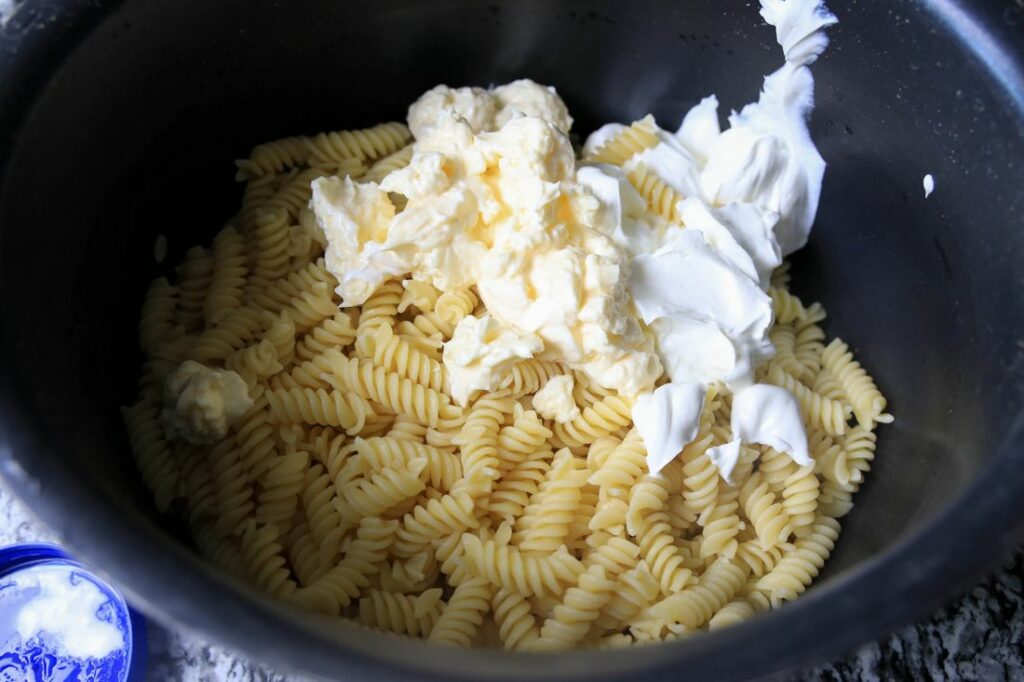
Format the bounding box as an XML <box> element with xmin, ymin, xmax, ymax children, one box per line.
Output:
<box><xmin>310</xmin><ymin>0</ymin><xmax>837</xmax><ymax>477</ymax></box>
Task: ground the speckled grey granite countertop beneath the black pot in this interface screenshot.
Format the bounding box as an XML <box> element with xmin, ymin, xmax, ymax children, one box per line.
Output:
<box><xmin>0</xmin><ymin>483</ymin><xmax>1024</xmax><ymax>682</ymax></box>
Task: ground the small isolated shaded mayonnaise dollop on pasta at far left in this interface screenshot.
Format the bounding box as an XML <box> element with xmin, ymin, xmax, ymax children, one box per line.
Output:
<box><xmin>162</xmin><ymin>360</ymin><xmax>253</xmax><ymax>444</ymax></box>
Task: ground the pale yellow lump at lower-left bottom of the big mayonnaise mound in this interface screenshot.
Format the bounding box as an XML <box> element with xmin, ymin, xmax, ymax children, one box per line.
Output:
<box><xmin>443</xmin><ymin>314</ymin><xmax>544</xmax><ymax>404</ymax></box>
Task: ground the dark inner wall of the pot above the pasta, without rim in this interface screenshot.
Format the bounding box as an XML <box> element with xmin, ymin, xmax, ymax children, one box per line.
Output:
<box><xmin>0</xmin><ymin>0</ymin><xmax>1024</xmax><ymax>675</ymax></box>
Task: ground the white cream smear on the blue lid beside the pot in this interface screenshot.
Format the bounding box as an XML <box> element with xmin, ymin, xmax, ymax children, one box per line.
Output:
<box><xmin>9</xmin><ymin>565</ymin><xmax>124</xmax><ymax>658</ymax></box>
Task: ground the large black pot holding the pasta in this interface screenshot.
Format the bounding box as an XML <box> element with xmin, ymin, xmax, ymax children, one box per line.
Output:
<box><xmin>0</xmin><ymin>0</ymin><xmax>1024</xmax><ymax>680</ymax></box>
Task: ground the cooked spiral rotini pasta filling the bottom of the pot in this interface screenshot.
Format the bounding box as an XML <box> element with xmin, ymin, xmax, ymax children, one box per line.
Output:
<box><xmin>124</xmin><ymin>118</ymin><xmax>891</xmax><ymax>649</ymax></box>
